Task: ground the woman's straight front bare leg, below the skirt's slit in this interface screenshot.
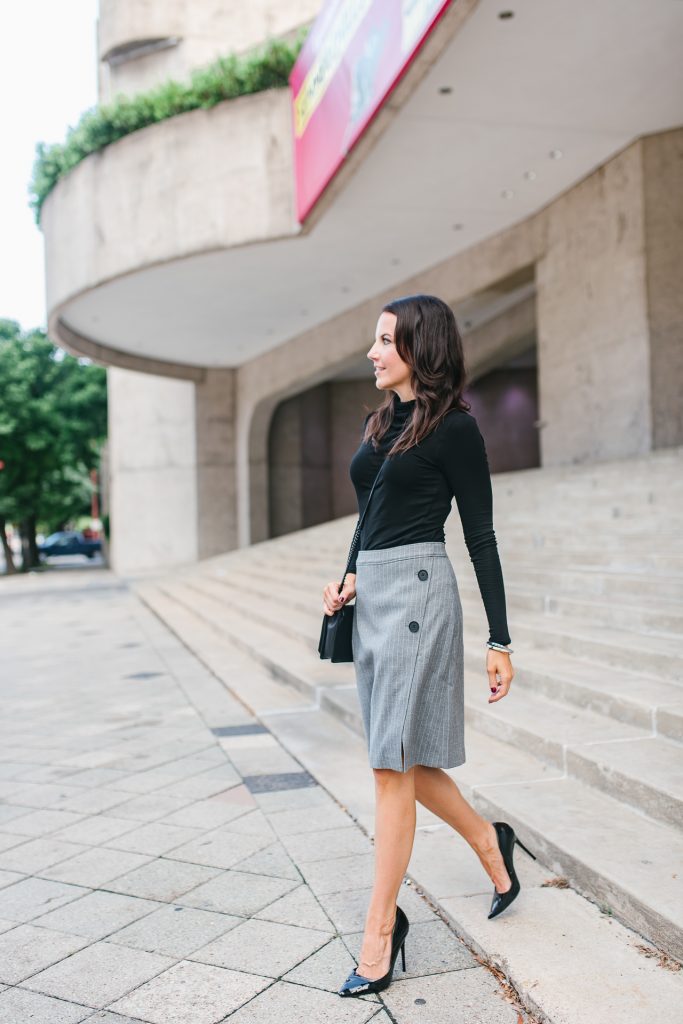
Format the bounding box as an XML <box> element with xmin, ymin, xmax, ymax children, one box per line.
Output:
<box><xmin>356</xmin><ymin>768</ymin><xmax>416</xmax><ymax>981</ymax></box>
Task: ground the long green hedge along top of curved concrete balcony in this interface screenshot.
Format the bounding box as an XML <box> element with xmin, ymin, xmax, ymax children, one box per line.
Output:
<box><xmin>30</xmin><ymin>28</ymin><xmax>308</xmax><ymax>223</ymax></box>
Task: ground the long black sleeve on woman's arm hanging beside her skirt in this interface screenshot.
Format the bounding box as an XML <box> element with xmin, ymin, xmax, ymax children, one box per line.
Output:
<box><xmin>439</xmin><ymin>413</ymin><xmax>511</xmax><ymax>644</ymax></box>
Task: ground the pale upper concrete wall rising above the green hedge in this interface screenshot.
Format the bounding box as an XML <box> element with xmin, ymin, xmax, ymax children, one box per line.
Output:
<box><xmin>98</xmin><ymin>0</ymin><xmax>321</xmax><ymax>101</ymax></box>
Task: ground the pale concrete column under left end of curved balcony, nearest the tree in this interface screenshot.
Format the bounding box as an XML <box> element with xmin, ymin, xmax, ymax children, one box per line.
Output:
<box><xmin>108</xmin><ymin>367</ymin><xmax>237</xmax><ymax>574</ymax></box>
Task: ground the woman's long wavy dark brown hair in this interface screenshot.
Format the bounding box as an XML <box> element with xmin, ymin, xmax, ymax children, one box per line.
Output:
<box><xmin>362</xmin><ymin>295</ymin><xmax>471</xmax><ymax>456</ymax></box>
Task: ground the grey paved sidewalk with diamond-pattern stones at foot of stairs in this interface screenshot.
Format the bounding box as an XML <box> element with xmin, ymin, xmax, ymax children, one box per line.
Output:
<box><xmin>0</xmin><ymin>570</ymin><xmax>529</xmax><ymax>1024</ymax></box>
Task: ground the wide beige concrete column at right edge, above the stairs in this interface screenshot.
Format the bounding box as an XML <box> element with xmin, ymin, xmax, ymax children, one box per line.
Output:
<box><xmin>537</xmin><ymin>130</ymin><xmax>683</xmax><ymax>466</ymax></box>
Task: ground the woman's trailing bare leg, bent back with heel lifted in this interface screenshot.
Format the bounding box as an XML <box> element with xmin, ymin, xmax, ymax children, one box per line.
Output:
<box><xmin>415</xmin><ymin>765</ymin><xmax>512</xmax><ymax>893</ymax></box>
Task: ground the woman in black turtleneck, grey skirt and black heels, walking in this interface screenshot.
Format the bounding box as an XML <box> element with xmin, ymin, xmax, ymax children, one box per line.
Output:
<box><xmin>324</xmin><ymin>295</ymin><xmax>532</xmax><ymax>995</ymax></box>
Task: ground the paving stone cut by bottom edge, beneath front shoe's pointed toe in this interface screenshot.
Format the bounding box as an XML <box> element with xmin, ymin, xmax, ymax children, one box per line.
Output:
<box><xmin>227</xmin><ymin>978</ymin><xmax>382</xmax><ymax>1024</ymax></box>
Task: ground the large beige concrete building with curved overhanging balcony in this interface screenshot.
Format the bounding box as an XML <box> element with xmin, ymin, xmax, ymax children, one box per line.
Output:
<box><xmin>42</xmin><ymin>0</ymin><xmax>683</xmax><ymax>573</ymax></box>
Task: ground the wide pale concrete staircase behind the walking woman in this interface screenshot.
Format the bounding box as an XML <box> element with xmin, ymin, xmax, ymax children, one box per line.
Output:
<box><xmin>135</xmin><ymin>449</ymin><xmax>683</xmax><ymax>1019</ymax></box>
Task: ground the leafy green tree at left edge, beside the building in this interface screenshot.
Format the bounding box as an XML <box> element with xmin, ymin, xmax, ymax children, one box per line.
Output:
<box><xmin>0</xmin><ymin>319</ymin><xmax>106</xmax><ymax>572</ymax></box>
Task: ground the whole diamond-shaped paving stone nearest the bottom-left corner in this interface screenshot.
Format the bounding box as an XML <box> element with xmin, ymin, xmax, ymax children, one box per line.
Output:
<box><xmin>24</xmin><ymin>942</ymin><xmax>173</xmax><ymax>1009</ymax></box>
